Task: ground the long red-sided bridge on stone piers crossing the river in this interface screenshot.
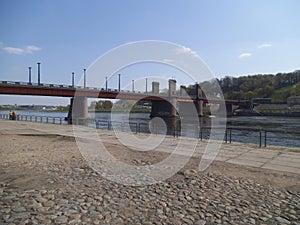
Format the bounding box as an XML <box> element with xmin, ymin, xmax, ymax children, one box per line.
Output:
<box><xmin>0</xmin><ymin>79</ymin><xmax>250</xmax><ymax>123</ymax></box>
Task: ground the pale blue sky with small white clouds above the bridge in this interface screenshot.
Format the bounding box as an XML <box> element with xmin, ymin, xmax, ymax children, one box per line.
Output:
<box><xmin>0</xmin><ymin>0</ymin><xmax>300</xmax><ymax>105</ymax></box>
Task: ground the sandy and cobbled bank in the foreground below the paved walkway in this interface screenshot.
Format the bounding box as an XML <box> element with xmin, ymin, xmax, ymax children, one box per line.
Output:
<box><xmin>0</xmin><ymin>131</ymin><xmax>300</xmax><ymax>224</ymax></box>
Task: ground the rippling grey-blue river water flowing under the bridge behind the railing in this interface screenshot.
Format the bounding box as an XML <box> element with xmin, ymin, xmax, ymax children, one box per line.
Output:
<box><xmin>0</xmin><ymin>110</ymin><xmax>300</xmax><ymax>147</ymax></box>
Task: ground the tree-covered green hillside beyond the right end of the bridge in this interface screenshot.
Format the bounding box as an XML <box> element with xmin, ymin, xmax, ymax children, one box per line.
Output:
<box><xmin>186</xmin><ymin>70</ymin><xmax>300</xmax><ymax>102</ymax></box>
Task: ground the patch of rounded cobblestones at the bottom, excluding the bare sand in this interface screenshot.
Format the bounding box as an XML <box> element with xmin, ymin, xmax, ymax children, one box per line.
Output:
<box><xmin>0</xmin><ymin>166</ymin><xmax>300</xmax><ymax>225</ymax></box>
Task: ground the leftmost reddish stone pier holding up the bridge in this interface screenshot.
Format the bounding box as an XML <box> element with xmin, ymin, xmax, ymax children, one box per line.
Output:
<box><xmin>67</xmin><ymin>96</ymin><xmax>88</xmax><ymax>125</ymax></box>
